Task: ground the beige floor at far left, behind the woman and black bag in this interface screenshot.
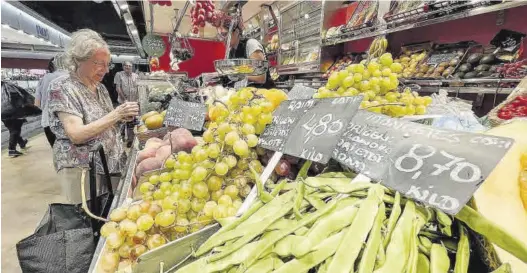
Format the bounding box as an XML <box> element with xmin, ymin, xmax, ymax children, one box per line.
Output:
<box><xmin>1</xmin><ymin>134</ymin><xmax>64</xmax><ymax>273</ymax></box>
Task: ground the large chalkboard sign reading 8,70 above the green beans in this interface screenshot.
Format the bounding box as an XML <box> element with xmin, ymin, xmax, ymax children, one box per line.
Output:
<box><xmin>333</xmin><ymin>111</ymin><xmax>513</xmax><ymax>214</ymax></box>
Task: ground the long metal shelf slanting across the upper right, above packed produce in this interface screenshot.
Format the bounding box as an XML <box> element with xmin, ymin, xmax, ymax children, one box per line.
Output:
<box><xmin>323</xmin><ymin>1</ymin><xmax>527</xmax><ymax>46</ymax></box>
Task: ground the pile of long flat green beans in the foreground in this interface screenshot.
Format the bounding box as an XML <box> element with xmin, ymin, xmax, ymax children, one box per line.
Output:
<box><xmin>176</xmin><ymin>175</ymin><xmax>527</xmax><ymax>273</ymax></box>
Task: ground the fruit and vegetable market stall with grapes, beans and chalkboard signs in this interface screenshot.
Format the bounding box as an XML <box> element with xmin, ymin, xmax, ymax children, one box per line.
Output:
<box><xmin>81</xmin><ymin>1</ymin><xmax>527</xmax><ymax>273</ymax></box>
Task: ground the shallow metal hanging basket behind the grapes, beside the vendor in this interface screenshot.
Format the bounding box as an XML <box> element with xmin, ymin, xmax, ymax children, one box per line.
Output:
<box><xmin>214</xmin><ymin>59</ymin><xmax>269</xmax><ymax>76</ymax></box>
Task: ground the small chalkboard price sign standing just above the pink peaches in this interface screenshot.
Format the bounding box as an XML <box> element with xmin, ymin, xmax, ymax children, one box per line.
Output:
<box><xmin>163</xmin><ymin>98</ymin><xmax>207</xmax><ymax>131</ymax></box>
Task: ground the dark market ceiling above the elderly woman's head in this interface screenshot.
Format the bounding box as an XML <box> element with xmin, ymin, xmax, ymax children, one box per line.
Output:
<box><xmin>21</xmin><ymin>1</ymin><xmax>145</xmax><ymax>54</ymax></box>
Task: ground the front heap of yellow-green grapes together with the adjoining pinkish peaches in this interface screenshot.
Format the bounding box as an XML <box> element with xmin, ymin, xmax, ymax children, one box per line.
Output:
<box><xmin>99</xmin><ymin>88</ymin><xmax>287</xmax><ymax>272</ymax></box>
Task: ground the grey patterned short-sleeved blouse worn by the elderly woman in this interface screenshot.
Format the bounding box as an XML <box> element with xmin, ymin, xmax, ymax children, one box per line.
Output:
<box><xmin>49</xmin><ymin>74</ymin><xmax>126</xmax><ymax>174</ymax></box>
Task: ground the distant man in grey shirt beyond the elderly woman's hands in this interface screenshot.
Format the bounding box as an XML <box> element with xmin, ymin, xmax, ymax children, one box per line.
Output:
<box><xmin>114</xmin><ymin>61</ymin><xmax>139</xmax><ymax>147</ymax></box>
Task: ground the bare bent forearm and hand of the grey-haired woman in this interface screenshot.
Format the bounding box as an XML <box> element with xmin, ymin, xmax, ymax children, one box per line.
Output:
<box><xmin>57</xmin><ymin>102</ymin><xmax>139</xmax><ymax>144</ymax></box>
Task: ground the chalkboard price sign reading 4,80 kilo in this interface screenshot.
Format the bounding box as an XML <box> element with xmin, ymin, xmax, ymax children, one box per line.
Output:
<box><xmin>259</xmin><ymin>96</ymin><xmax>362</xmax><ymax>164</ymax></box>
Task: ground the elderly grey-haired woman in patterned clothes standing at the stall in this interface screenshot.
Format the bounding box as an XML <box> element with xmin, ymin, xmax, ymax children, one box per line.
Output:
<box><xmin>48</xmin><ymin>29</ymin><xmax>139</xmax><ymax>203</ymax></box>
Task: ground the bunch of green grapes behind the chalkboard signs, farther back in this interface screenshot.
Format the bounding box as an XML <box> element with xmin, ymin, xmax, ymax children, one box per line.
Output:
<box><xmin>313</xmin><ymin>53</ymin><xmax>432</xmax><ymax>117</ymax></box>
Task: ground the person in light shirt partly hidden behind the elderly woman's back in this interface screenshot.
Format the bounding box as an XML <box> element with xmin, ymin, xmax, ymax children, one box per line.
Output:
<box><xmin>35</xmin><ymin>53</ymin><xmax>68</xmax><ymax>148</ymax></box>
